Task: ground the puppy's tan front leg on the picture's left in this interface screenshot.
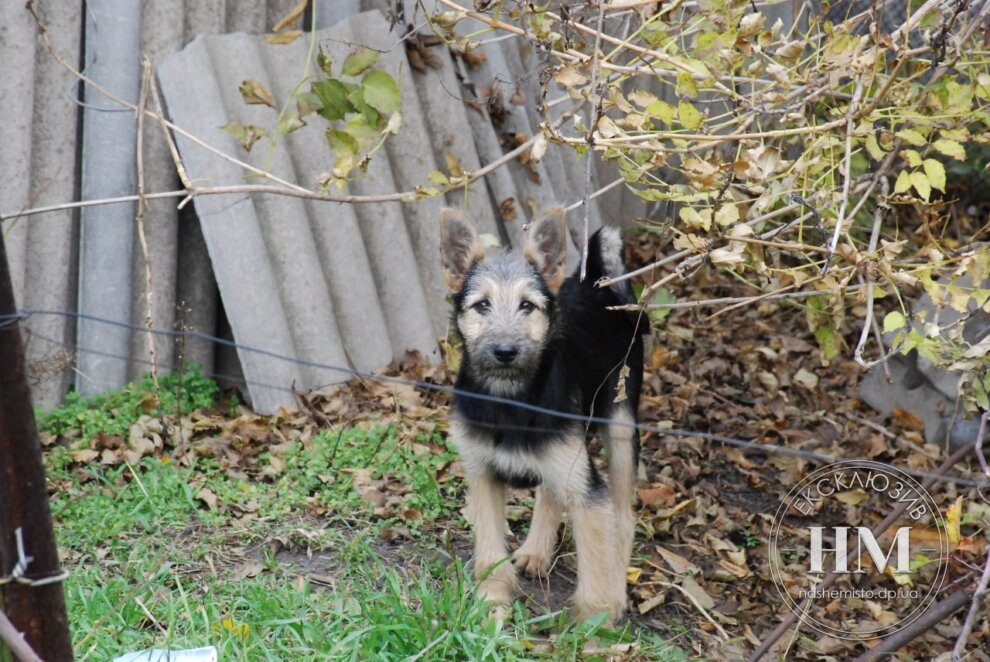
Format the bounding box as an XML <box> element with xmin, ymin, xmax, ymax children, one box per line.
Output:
<box><xmin>468</xmin><ymin>473</ymin><xmax>516</xmax><ymax>605</ymax></box>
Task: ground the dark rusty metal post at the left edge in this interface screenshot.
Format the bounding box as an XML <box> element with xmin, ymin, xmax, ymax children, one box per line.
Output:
<box><xmin>0</xmin><ymin>232</ymin><xmax>72</xmax><ymax>662</ymax></box>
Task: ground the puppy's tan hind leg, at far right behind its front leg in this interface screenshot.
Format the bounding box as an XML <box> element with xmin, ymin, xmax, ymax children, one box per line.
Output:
<box><xmin>604</xmin><ymin>403</ymin><xmax>639</xmax><ymax>596</ymax></box>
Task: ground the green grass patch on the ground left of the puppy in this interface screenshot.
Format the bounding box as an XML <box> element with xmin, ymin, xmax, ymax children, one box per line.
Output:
<box><xmin>42</xmin><ymin>375</ymin><xmax>685</xmax><ymax>662</ymax></box>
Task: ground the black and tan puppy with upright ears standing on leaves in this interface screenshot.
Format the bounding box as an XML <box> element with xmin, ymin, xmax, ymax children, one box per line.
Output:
<box><xmin>440</xmin><ymin>208</ymin><xmax>643</xmax><ymax>618</ymax></box>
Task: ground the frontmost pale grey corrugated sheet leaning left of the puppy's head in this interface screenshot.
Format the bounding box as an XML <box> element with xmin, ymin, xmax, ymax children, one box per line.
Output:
<box><xmin>159</xmin><ymin>13</ymin><xmax>446</xmax><ymax>412</ymax></box>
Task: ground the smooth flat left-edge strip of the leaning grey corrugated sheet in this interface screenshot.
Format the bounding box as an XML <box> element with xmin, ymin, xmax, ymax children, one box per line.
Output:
<box><xmin>158</xmin><ymin>37</ymin><xmax>303</xmax><ymax>413</ymax></box>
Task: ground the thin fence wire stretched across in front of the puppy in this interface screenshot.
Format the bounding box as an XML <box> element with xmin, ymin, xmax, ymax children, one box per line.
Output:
<box><xmin>0</xmin><ymin>309</ymin><xmax>990</xmax><ymax>489</ymax></box>
